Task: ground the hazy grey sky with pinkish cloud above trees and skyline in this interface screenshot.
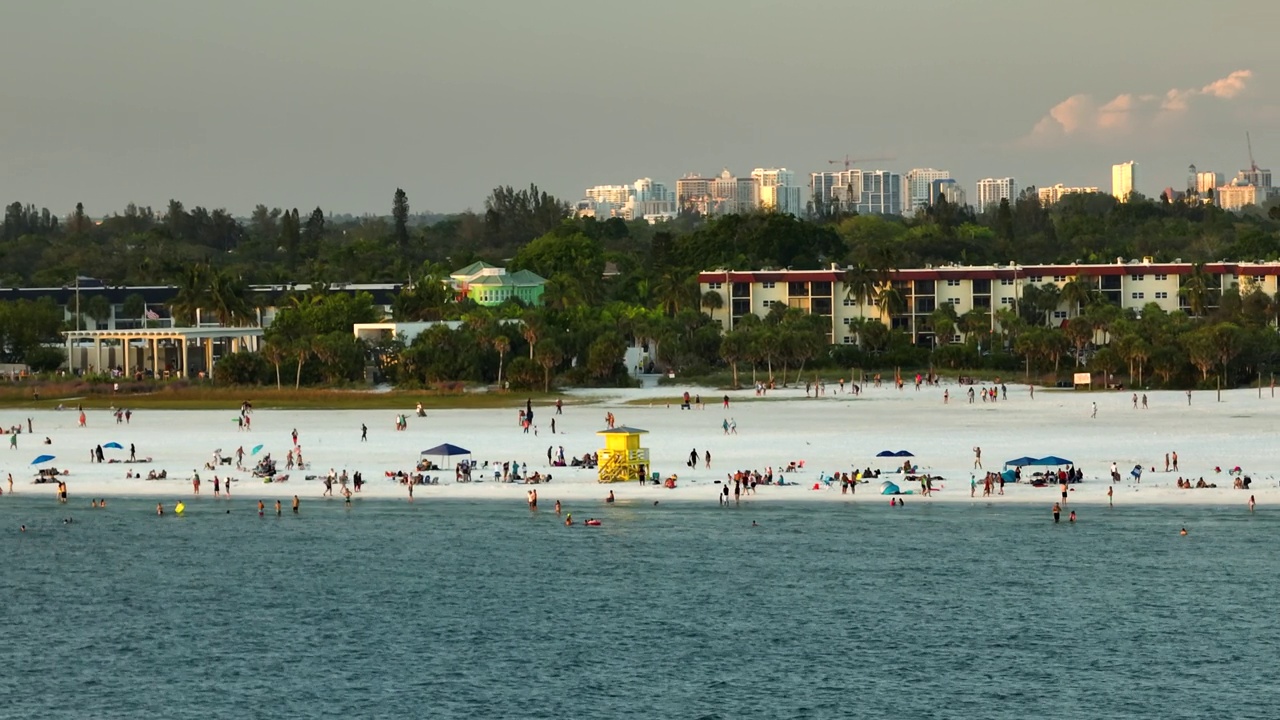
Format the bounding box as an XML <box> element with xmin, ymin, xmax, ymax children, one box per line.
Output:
<box><xmin>0</xmin><ymin>0</ymin><xmax>1280</xmax><ymax>215</ymax></box>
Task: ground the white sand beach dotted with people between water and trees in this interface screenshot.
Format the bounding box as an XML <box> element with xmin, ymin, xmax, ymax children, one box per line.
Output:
<box><xmin>0</xmin><ymin>383</ymin><xmax>1280</xmax><ymax>507</ymax></box>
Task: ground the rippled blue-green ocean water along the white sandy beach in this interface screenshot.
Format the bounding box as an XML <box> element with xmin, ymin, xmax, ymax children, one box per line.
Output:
<box><xmin>0</xmin><ymin>493</ymin><xmax>1280</xmax><ymax>719</ymax></box>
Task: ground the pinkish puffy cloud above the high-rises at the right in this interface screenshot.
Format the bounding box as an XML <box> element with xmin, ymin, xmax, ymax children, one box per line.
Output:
<box><xmin>1021</xmin><ymin>70</ymin><xmax>1253</xmax><ymax>145</ymax></box>
